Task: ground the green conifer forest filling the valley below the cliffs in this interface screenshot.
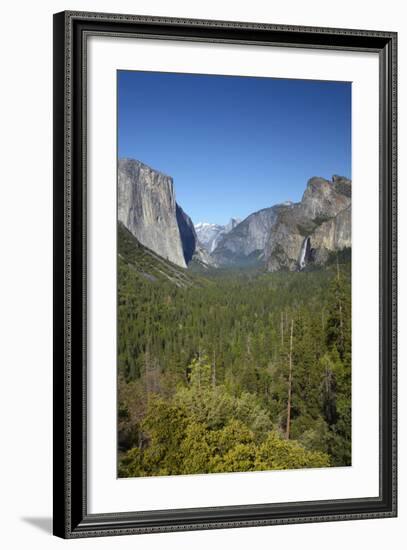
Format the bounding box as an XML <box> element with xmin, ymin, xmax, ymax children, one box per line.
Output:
<box><xmin>117</xmin><ymin>224</ymin><xmax>351</xmax><ymax>477</ymax></box>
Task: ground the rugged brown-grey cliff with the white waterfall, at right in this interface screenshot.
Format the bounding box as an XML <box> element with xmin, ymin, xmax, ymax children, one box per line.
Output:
<box><xmin>265</xmin><ymin>176</ymin><xmax>352</xmax><ymax>271</ymax></box>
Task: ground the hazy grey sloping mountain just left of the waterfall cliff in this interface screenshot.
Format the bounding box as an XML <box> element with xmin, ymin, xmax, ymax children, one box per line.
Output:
<box><xmin>211</xmin><ymin>205</ymin><xmax>286</xmax><ymax>266</ymax></box>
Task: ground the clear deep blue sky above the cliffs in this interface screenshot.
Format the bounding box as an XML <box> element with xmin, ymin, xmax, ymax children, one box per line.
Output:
<box><xmin>118</xmin><ymin>71</ymin><xmax>351</xmax><ymax>224</ymax></box>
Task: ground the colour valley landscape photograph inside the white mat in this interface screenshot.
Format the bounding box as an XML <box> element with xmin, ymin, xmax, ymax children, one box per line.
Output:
<box><xmin>116</xmin><ymin>70</ymin><xmax>352</xmax><ymax>478</ymax></box>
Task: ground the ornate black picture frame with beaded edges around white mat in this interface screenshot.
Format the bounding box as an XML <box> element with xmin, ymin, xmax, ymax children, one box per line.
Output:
<box><xmin>54</xmin><ymin>12</ymin><xmax>397</xmax><ymax>538</ymax></box>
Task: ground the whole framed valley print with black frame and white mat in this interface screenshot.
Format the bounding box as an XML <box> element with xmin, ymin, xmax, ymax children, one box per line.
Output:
<box><xmin>54</xmin><ymin>12</ymin><xmax>397</xmax><ymax>538</ymax></box>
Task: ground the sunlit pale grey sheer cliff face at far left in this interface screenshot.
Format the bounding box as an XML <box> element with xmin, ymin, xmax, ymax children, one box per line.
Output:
<box><xmin>118</xmin><ymin>159</ymin><xmax>188</xmax><ymax>267</ymax></box>
